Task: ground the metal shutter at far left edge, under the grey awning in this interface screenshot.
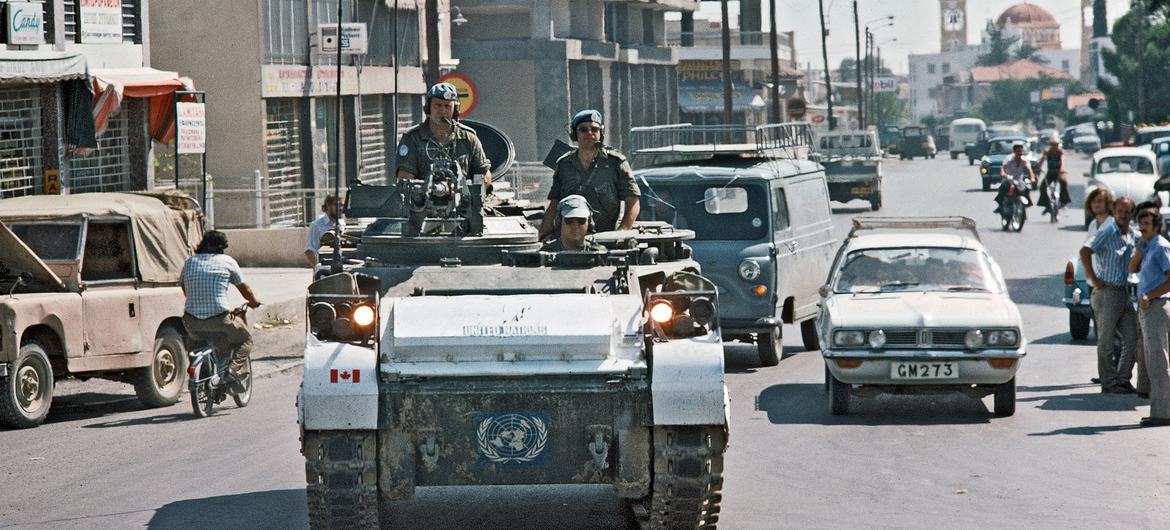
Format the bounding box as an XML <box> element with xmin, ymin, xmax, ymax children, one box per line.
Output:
<box><xmin>0</xmin><ymin>89</ymin><xmax>41</xmax><ymax>198</ymax></box>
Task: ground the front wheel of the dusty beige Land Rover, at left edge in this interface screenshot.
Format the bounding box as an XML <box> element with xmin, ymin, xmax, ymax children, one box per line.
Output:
<box><xmin>0</xmin><ymin>343</ymin><xmax>53</xmax><ymax>428</ymax></box>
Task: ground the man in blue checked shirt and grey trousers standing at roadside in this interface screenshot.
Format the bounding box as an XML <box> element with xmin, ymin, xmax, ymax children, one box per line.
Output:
<box><xmin>1081</xmin><ymin>197</ymin><xmax>1137</xmax><ymax>394</ymax></box>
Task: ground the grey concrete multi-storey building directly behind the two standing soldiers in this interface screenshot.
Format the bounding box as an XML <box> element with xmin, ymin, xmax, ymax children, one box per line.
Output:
<box><xmin>452</xmin><ymin>0</ymin><xmax>698</xmax><ymax>161</ymax></box>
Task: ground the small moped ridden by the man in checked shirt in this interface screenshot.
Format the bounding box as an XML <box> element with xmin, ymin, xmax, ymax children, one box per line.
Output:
<box><xmin>187</xmin><ymin>304</ymin><xmax>252</xmax><ymax>418</ymax></box>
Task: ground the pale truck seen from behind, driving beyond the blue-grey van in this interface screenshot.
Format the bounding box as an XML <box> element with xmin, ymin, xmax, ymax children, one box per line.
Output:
<box><xmin>815</xmin><ymin>130</ymin><xmax>882</xmax><ymax>211</ymax></box>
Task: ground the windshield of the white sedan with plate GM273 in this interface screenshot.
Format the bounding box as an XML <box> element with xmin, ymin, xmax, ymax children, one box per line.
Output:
<box><xmin>833</xmin><ymin>247</ymin><xmax>1000</xmax><ymax>292</ymax></box>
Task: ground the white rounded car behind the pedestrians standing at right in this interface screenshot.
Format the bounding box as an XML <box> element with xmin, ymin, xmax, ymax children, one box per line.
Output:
<box><xmin>1085</xmin><ymin>147</ymin><xmax>1168</xmax><ymax>226</ymax></box>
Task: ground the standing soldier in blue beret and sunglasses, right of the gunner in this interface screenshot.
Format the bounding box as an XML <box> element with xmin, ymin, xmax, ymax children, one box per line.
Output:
<box><xmin>541</xmin><ymin>109</ymin><xmax>641</xmax><ymax>239</ymax></box>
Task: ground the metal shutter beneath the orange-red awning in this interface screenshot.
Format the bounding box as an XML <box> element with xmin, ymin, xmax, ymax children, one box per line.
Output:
<box><xmin>66</xmin><ymin>109</ymin><xmax>130</xmax><ymax>193</ymax></box>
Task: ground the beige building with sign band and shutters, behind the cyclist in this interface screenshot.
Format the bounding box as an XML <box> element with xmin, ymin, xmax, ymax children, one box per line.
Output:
<box><xmin>151</xmin><ymin>0</ymin><xmax>435</xmax><ymax>227</ymax></box>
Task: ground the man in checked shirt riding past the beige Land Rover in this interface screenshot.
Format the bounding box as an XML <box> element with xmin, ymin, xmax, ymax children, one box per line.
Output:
<box><xmin>179</xmin><ymin>230</ymin><xmax>260</xmax><ymax>380</ymax></box>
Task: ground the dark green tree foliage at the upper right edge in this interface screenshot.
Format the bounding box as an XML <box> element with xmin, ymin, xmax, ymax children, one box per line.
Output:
<box><xmin>1100</xmin><ymin>1</ymin><xmax>1170</xmax><ymax>123</ymax></box>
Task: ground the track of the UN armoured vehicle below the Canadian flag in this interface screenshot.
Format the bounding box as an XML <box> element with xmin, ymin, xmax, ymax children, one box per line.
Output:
<box><xmin>302</xmin><ymin>431</ymin><xmax>381</xmax><ymax>529</ymax></box>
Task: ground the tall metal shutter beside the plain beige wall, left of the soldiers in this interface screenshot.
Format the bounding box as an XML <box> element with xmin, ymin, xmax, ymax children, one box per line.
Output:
<box><xmin>264</xmin><ymin>98</ymin><xmax>304</xmax><ymax>225</ymax></box>
